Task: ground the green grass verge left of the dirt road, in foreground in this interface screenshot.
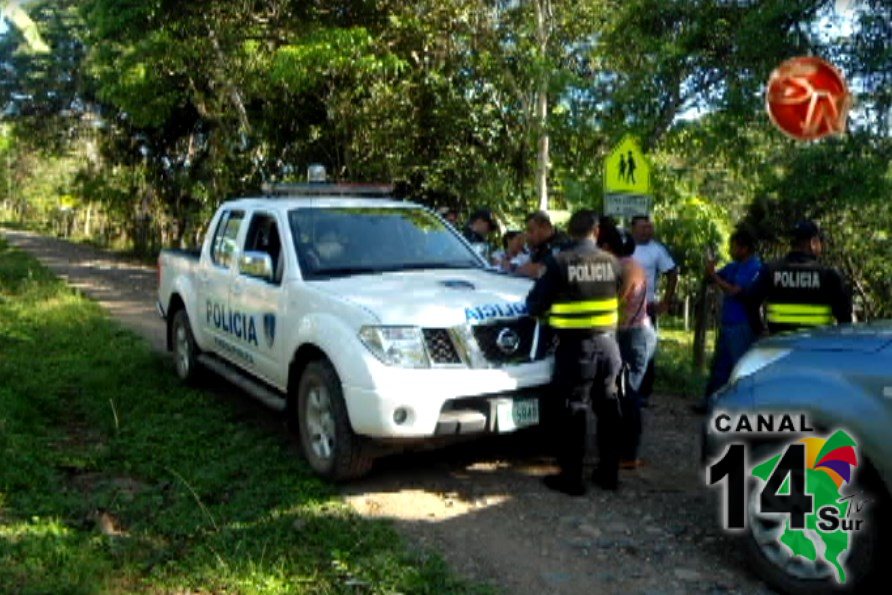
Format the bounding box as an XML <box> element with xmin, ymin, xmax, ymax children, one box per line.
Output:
<box><xmin>0</xmin><ymin>240</ymin><xmax>491</xmax><ymax>594</ymax></box>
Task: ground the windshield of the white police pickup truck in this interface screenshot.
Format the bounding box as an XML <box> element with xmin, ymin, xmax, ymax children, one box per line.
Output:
<box><xmin>288</xmin><ymin>207</ymin><xmax>483</xmax><ymax>279</ymax></box>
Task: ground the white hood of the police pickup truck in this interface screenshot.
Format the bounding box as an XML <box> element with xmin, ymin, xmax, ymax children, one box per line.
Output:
<box><xmin>311</xmin><ymin>269</ymin><xmax>533</xmax><ymax>328</ymax></box>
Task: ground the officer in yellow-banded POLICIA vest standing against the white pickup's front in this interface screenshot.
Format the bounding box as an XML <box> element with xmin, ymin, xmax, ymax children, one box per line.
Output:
<box><xmin>526</xmin><ymin>210</ymin><xmax>622</xmax><ymax>496</ymax></box>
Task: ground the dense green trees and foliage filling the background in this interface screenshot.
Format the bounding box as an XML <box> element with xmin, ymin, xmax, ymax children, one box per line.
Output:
<box><xmin>0</xmin><ymin>0</ymin><xmax>892</xmax><ymax>316</ymax></box>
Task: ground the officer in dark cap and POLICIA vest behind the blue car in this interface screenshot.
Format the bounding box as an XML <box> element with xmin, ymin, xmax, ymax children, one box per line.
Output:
<box><xmin>750</xmin><ymin>220</ymin><xmax>852</xmax><ymax>335</ymax></box>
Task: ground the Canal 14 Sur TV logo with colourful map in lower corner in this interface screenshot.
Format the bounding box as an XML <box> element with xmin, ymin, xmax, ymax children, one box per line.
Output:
<box><xmin>706</xmin><ymin>413</ymin><xmax>868</xmax><ymax>584</ymax></box>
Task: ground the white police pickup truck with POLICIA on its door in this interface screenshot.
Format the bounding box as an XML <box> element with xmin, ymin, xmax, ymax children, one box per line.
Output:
<box><xmin>158</xmin><ymin>185</ymin><xmax>552</xmax><ymax>479</ymax></box>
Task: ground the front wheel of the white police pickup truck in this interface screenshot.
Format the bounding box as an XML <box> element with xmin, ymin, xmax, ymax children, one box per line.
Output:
<box><xmin>296</xmin><ymin>360</ymin><xmax>373</xmax><ymax>481</ymax></box>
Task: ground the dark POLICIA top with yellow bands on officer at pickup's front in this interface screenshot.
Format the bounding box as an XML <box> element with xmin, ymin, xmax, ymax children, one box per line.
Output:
<box><xmin>526</xmin><ymin>240</ymin><xmax>622</xmax><ymax>336</ymax></box>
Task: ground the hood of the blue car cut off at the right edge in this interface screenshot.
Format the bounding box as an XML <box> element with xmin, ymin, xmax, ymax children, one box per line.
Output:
<box><xmin>759</xmin><ymin>320</ymin><xmax>892</xmax><ymax>353</ymax></box>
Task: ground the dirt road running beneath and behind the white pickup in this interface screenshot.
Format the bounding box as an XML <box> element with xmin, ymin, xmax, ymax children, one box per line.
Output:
<box><xmin>0</xmin><ymin>230</ymin><xmax>771</xmax><ymax>594</ymax></box>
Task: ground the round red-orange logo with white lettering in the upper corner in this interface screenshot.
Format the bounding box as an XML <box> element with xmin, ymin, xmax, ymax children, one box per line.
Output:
<box><xmin>765</xmin><ymin>56</ymin><xmax>851</xmax><ymax>140</ymax></box>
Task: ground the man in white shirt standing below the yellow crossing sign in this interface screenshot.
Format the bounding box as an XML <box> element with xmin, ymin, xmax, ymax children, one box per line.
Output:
<box><xmin>631</xmin><ymin>215</ymin><xmax>678</xmax><ymax>403</ymax></box>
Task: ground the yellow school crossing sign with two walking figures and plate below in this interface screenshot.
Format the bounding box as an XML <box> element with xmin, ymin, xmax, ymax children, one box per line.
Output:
<box><xmin>604</xmin><ymin>134</ymin><xmax>653</xmax><ymax>217</ymax></box>
